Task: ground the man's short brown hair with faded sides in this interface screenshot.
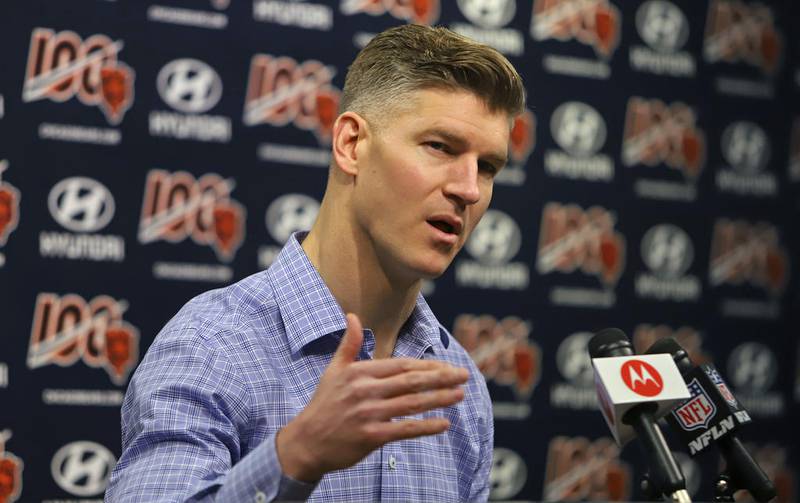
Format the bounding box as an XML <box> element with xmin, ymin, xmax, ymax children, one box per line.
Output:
<box><xmin>340</xmin><ymin>24</ymin><xmax>525</xmax><ymax>122</ymax></box>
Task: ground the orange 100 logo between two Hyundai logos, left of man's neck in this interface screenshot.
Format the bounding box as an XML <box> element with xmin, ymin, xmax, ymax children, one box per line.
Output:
<box><xmin>139</xmin><ymin>169</ymin><xmax>246</xmax><ymax>262</ymax></box>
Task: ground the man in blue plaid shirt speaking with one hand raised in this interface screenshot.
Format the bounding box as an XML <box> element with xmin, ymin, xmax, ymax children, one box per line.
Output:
<box><xmin>106</xmin><ymin>25</ymin><xmax>524</xmax><ymax>501</ymax></box>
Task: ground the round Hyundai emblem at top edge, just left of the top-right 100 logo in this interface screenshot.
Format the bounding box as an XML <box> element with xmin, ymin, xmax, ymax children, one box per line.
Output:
<box><xmin>636</xmin><ymin>0</ymin><xmax>689</xmax><ymax>53</ymax></box>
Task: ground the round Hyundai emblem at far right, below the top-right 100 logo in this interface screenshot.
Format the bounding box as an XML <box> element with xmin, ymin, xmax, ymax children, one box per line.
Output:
<box><xmin>721</xmin><ymin>121</ymin><xmax>770</xmax><ymax>174</ymax></box>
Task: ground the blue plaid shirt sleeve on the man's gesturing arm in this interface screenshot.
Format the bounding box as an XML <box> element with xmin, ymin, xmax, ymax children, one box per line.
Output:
<box><xmin>105</xmin><ymin>329</ymin><xmax>315</xmax><ymax>503</ymax></box>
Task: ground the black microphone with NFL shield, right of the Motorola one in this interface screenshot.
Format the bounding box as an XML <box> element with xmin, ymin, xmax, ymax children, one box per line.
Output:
<box><xmin>647</xmin><ymin>337</ymin><xmax>777</xmax><ymax>502</ymax></box>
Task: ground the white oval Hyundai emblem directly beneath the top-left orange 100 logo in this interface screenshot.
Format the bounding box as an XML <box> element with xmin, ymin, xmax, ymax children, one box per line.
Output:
<box><xmin>47</xmin><ymin>176</ymin><xmax>114</xmax><ymax>232</ymax></box>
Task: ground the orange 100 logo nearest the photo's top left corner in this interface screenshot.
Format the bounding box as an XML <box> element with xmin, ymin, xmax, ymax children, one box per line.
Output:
<box><xmin>22</xmin><ymin>28</ymin><xmax>134</xmax><ymax>124</ymax></box>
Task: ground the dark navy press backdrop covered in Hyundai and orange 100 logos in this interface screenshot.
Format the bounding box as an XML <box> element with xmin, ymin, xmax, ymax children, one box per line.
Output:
<box><xmin>0</xmin><ymin>0</ymin><xmax>800</xmax><ymax>501</ymax></box>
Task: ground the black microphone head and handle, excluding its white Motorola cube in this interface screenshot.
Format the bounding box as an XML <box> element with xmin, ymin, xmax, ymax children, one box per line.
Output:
<box><xmin>587</xmin><ymin>328</ymin><xmax>691</xmax><ymax>501</ymax></box>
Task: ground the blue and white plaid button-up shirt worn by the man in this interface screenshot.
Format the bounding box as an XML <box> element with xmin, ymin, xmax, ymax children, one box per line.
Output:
<box><xmin>106</xmin><ymin>234</ymin><xmax>494</xmax><ymax>502</ymax></box>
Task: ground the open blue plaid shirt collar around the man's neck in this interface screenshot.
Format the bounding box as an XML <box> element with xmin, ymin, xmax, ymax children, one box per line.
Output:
<box><xmin>268</xmin><ymin>232</ymin><xmax>449</xmax><ymax>356</ymax></box>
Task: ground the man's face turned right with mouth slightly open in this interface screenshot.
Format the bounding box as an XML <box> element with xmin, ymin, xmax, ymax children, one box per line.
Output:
<box><xmin>353</xmin><ymin>90</ymin><xmax>510</xmax><ymax>280</ymax></box>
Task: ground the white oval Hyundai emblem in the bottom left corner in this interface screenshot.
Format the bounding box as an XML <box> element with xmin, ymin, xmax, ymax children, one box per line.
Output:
<box><xmin>50</xmin><ymin>440</ymin><xmax>117</xmax><ymax>496</ymax></box>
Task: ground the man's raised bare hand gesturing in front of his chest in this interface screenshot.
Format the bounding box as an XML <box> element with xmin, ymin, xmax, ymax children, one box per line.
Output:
<box><xmin>276</xmin><ymin>314</ymin><xmax>469</xmax><ymax>482</ymax></box>
